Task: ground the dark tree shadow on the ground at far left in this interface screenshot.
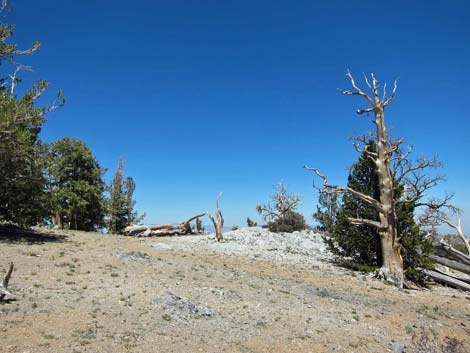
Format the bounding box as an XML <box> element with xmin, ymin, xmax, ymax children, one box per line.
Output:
<box><xmin>0</xmin><ymin>224</ymin><xmax>67</xmax><ymax>244</ymax></box>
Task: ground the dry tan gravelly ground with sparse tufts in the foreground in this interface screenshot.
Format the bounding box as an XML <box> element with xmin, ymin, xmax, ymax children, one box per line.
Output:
<box><xmin>0</xmin><ymin>232</ymin><xmax>470</xmax><ymax>353</ymax></box>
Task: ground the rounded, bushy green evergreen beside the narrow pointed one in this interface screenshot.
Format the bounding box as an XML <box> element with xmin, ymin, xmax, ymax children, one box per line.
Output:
<box><xmin>47</xmin><ymin>137</ymin><xmax>106</xmax><ymax>231</ymax></box>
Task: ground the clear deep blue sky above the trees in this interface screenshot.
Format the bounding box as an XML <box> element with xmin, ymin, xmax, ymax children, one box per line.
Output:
<box><xmin>8</xmin><ymin>0</ymin><xmax>470</xmax><ymax>231</ymax></box>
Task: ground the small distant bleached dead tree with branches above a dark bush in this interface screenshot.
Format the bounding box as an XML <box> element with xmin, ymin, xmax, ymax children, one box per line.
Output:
<box><xmin>256</xmin><ymin>182</ymin><xmax>301</xmax><ymax>220</ymax></box>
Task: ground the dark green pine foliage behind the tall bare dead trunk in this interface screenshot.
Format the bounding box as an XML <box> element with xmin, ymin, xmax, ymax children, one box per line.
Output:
<box><xmin>325</xmin><ymin>141</ymin><xmax>433</xmax><ymax>283</ymax></box>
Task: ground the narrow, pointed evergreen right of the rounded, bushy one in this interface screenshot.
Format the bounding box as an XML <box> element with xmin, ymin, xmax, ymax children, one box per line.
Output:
<box><xmin>108</xmin><ymin>158</ymin><xmax>144</xmax><ymax>233</ymax></box>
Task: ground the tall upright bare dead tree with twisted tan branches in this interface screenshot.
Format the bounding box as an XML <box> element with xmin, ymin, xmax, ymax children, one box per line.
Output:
<box><xmin>304</xmin><ymin>71</ymin><xmax>456</xmax><ymax>288</ymax></box>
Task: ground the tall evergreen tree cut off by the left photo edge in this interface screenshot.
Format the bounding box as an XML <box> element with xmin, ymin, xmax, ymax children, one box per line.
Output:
<box><xmin>0</xmin><ymin>1</ymin><xmax>64</xmax><ymax>226</ymax></box>
